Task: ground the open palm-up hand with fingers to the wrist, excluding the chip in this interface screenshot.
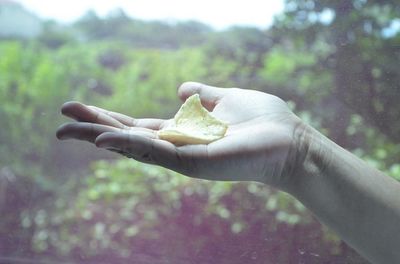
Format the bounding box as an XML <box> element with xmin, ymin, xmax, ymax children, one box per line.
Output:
<box><xmin>57</xmin><ymin>82</ymin><xmax>301</xmax><ymax>190</ymax></box>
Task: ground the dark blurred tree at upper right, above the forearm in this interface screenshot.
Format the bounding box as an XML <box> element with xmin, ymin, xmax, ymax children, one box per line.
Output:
<box><xmin>274</xmin><ymin>0</ymin><xmax>400</xmax><ymax>141</ymax></box>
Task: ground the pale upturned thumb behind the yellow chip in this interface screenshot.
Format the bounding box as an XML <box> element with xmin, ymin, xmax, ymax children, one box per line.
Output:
<box><xmin>178</xmin><ymin>82</ymin><xmax>228</xmax><ymax>111</ymax></box>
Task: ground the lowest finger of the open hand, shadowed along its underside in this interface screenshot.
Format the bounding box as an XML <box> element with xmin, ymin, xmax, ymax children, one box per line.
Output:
<box><xmin>95</xmin><ymin>132</ymin><xmax>203</xmax><ymax>175</ymax></box>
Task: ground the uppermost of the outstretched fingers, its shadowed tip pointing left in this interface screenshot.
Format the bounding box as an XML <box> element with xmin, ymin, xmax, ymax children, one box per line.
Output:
<box><xmin>61</xmin><ymin>102</ymin><xmax>125</xmax><ymax>128</ymax></box>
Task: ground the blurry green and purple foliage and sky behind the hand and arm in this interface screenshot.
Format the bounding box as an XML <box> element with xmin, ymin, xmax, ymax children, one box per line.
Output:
<box><xmin>0</xmin><ymin>0</ymin><xmax>400</xmax><ymax>264</ymax></box>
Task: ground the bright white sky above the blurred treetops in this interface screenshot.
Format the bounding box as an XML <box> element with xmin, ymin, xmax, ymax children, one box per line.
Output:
<box><xmin>17</xmin><ymin>0</ymin><xmax>283</xmax><ymax>29</ymax></box>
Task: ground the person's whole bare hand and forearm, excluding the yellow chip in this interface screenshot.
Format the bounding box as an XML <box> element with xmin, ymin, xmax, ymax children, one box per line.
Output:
<box><xmin>57</xmin><ymin>82</ymin><xmax>400</xmax><ymax>263</ymax></box>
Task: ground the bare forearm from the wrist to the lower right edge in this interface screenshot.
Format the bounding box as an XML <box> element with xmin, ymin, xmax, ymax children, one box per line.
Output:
<box><xmin>290</xmin><ymin>124</ymin><xmax>400</xmax><ymax>263</ymax></box>
